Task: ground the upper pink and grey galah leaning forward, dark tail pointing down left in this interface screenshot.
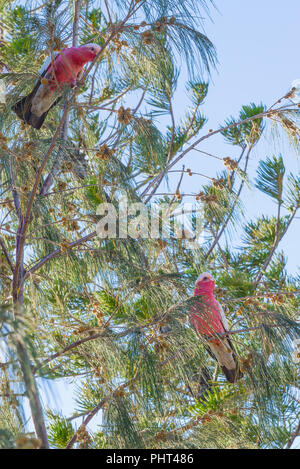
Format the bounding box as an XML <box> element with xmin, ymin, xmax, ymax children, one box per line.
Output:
<box><xmin>12</xmin><ymin>44</ymin><xmax>100</xmax><ymax>129</ymax></box>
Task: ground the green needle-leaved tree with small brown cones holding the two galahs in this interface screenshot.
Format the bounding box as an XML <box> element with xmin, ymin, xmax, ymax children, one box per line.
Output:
<box><xmin>0</xmin><ymin>0</ymin><xmax>300</xmax><ymax>449</ymax></box>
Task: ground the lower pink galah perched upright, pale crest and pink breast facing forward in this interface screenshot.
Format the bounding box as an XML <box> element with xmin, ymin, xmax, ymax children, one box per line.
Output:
<box><xmin>190</xmin><ymin>272</ymin><xmax>243</xmax><ymax>383</ymax></box>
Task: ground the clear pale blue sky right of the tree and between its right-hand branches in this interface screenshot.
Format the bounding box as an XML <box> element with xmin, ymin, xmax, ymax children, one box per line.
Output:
<box><xmin>161</xmin><ymin>0</ymin><xmax>300</xmax><ymax>274</ymax></box>
